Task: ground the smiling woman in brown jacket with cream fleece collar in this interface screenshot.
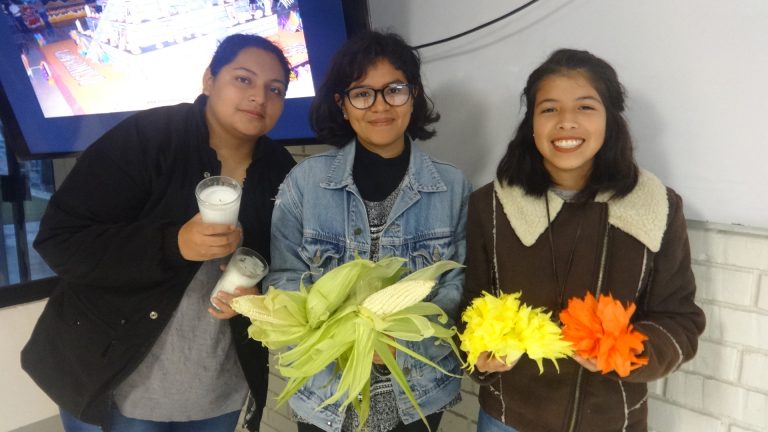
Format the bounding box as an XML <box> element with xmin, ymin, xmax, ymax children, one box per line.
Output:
<box><xmin>463</xmin><ymin>49</ymin><xmax>705</xmax><ymax>432</ymax></box>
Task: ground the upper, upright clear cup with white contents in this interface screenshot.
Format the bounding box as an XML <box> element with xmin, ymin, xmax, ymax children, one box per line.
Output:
<box><xmin>195</xmin><ymin>176</ymin><xmax>243</xmax><ymax>225</ymax></box>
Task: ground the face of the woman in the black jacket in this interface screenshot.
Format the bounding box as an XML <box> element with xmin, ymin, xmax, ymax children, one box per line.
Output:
<box><xmin>203</xmin><ymin>48</ymin><xmax>288</xmax><ymax>148</ymax></box>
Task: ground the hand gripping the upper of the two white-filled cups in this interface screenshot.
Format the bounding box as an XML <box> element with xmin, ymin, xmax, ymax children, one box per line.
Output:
<box><xmin>178</xmin><ymin>213</ymin><xmax>243</xmax><ymax>261</ymax></box>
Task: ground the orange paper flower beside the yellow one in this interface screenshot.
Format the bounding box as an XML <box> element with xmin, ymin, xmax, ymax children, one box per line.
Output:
<box><xmin>560</xmin><ymin>293</ymin><xmax>648</xmax><ymax>377</ymax></box>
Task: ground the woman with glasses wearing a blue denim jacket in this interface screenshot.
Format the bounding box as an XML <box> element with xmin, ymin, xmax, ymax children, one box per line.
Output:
<box><xmin>267</xmin><ymin>32</ymin><xmax>471</xmax><ymax>431</ymax></box>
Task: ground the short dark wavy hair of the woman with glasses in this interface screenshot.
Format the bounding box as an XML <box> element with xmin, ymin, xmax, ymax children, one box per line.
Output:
<box><xmin>309</xmin><ymin>31</ymin><xmax>440</xmax><ymax>147</ymax></box>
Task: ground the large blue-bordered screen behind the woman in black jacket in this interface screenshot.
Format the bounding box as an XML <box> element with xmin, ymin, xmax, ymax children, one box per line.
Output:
<box><xmin>0</xmin><ymin>0</ymin><xmax>365</xmax><ymax>159</ymax></box>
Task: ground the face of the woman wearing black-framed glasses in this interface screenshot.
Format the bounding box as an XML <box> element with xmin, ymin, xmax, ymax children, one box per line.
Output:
<box><xmin>338</xmin><ymin>60</ymin><xmax>413</xmax><ymax>158</ymax></box>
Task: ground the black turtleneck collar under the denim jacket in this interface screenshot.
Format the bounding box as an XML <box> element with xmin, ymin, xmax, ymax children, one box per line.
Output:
<box><xmin>352</xmin><ymin>137</ymin><xmax>411</xmax><ymax>202</ymax></box>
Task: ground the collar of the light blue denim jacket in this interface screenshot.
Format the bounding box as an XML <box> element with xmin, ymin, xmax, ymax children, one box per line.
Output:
<box><xmin>320</xmin><ymin>139</ymin><xmax>448</xmax><ymax>192</ymax></box>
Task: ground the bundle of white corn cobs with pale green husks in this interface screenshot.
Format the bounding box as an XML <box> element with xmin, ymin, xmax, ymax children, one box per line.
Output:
<box><xmin>232</xmin><ymin>257</ymin><xmax>461</xmax><ymax>427</ymax></box>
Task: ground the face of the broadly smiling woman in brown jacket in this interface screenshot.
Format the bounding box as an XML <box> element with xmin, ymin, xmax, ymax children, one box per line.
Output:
<box><xmin>533</xmin><ymin>72</ymin><xmax>606</xmax><ymax>190</ymax></box>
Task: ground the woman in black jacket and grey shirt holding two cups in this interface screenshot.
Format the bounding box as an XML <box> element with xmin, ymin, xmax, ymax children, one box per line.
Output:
<box><xmin>22</xmin><ymin>35</ymin><xmax>294</xmax><ymax>432</ymax></box>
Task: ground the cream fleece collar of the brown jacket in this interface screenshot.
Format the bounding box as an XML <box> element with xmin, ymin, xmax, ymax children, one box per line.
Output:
<box><xmin>493</xmin><ymin>169</ymin><xmax>669</xmax><ymax>252</ymax></box>
